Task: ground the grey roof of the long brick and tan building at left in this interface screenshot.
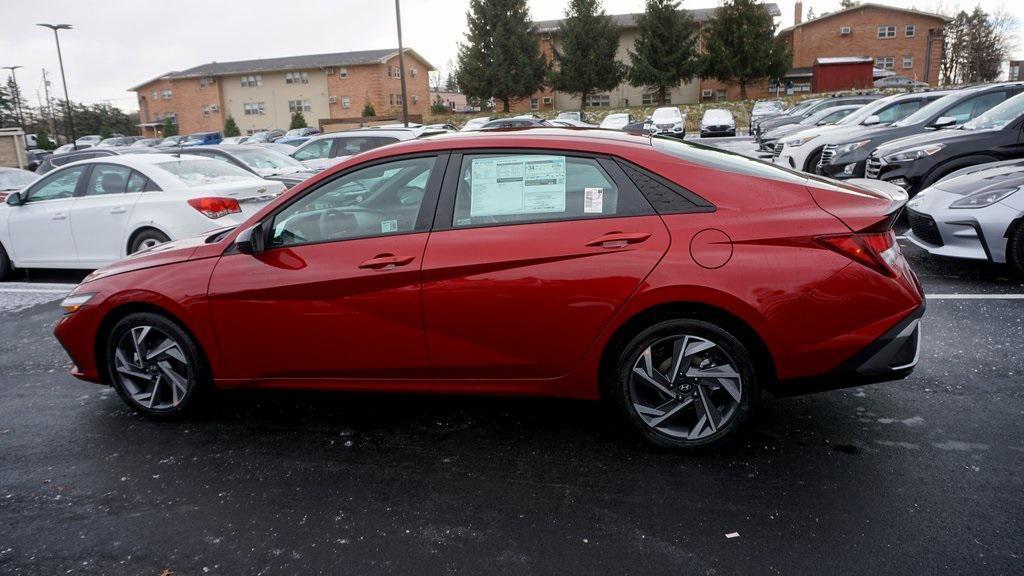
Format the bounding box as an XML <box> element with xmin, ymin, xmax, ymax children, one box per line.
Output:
<box><xmin>129</xmin><ymin>48</ymin><xmax>434</xmax><ymax>90</ymax></box>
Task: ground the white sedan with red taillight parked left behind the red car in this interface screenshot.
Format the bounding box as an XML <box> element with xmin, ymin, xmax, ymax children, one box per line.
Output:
<box><xmin>0</xmin><ymin>154</ymin><xmax>285</xmax><ymax>277</ymax></box>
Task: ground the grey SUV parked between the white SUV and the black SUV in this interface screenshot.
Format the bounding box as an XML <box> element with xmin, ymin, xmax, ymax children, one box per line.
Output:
<box><xmin>818</xmin><ymin>82</ymin><xmax>1024</xmax><ymax>178</ymax></box>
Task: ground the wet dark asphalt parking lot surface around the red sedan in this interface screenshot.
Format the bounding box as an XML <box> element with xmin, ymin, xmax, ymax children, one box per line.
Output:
<box><xmin>0</xmin><ymin>148</ymin><xmax>1024</xmax><ymax>576</ymax></box>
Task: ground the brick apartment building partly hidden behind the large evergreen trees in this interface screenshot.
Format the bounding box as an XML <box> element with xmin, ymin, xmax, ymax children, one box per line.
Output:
<box><xmin>528</xmin><ymin>1</ymin><xmax>948</xmax><ymax>111</ymax></box>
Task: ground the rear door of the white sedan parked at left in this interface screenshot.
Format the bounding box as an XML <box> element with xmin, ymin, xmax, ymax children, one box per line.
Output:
<box><xmin>71</xmin><ymin>164</ymin><xmax>148</xmax><ymax>266</ymax></box>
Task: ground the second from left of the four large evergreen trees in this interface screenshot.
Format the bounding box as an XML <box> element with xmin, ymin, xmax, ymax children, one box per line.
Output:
<box><xmin>550</xmin><ymin>0</ymin><xmax>626</xmax><ymax>112</ymax></box>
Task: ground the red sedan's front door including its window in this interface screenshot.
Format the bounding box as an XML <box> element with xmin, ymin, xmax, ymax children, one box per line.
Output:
<box><xmin>209</xmin><ymin>155</ymin><xmax>447</xmax><ymax>383</ymax></box>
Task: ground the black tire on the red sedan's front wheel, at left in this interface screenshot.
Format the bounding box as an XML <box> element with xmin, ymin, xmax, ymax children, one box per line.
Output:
<box><xmin>104</xmin><ymin>313</ymin><xmax>212</xmax><ymax>420</ymax></box>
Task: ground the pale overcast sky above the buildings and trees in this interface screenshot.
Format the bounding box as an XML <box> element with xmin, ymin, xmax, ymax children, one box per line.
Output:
<box><xmin>0</xmin><ymin>0</ymin><xmax>1024</xmax><ymax>111</ymax></box>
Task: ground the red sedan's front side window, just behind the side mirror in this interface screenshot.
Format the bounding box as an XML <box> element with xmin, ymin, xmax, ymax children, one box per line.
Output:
<box><xmin>270</xmin><ymin>157</ymin><xmax>436</xmax><ymax>247</ymax></box>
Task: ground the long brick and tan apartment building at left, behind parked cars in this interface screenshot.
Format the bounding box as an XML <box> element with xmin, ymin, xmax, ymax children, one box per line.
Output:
<box><xmin>130</xmin><ymin>48</ymin><xmax>433</xmax><ymax>136</ymax></box>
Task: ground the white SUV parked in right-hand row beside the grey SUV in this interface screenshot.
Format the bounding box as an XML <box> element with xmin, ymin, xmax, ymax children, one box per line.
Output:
<box><xmin>774</xmin><ymin>90</ymin><xmax>951</xmax><ymax>173</ymax></box>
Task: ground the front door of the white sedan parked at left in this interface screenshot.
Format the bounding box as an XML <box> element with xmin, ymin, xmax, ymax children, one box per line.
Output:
<box><xmin>7</xmin><ymin>166</ymin><xmax>88</xmax><ymax>268</ymax></box>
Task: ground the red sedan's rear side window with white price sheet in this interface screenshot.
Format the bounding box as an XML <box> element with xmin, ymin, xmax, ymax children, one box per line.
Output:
<box><xmin>452</xmin><ymin>154</ymin><xmax>650</xmax><ymax>228</ymax></box>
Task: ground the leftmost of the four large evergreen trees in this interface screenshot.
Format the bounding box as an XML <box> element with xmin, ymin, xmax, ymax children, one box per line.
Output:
<box><xmin>456</xmin><ymin>0</ymin><xmax>548</xmax><ymax>112</ymax></box>
